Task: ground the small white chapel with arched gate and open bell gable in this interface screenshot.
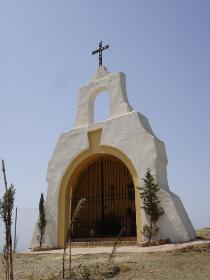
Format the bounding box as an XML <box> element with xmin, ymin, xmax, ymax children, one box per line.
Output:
<box><xmin>31</xmin><ymin>49</ymin><xmax>195</xmax><ymax>248</ymax></box>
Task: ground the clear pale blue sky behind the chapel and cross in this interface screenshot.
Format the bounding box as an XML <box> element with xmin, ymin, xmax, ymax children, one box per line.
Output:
<box><xmin>0</xmin><ymin>0</ymin><xmax>210</xmax><ymax>241</ymax></box>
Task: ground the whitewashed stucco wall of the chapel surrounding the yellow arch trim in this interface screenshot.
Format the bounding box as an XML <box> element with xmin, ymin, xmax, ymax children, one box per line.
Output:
<box><xmin>32</xmin><ymin>68</ymin><xmax>195</xmax><ymax>247</ymax></box>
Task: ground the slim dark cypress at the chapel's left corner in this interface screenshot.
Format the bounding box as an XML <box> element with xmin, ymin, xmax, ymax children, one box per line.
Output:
<box><xmin>37</xmin><ymin>193</ymin><xmax>47</xmax><ymax>247</ymax></box>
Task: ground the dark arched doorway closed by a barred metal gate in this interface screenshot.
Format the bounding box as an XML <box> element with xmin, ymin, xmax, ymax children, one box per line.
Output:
<box><xmin>71</xmin><ymin>154</ymin><xmax>136</xmax><ymax>241</ymax></box>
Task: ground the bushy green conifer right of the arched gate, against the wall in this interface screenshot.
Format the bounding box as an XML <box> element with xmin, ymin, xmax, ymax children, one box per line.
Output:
<box><xmin>139</xmin><ymin>169</ymin><xmax>164</xmax><ymax>243</ymax></box>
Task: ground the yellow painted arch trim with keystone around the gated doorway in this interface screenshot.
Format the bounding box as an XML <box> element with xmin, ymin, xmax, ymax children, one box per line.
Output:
<box><xmin>57</xmin><ymin>131</ymin><xmax>142</xmax><ymax>248</ymax></box>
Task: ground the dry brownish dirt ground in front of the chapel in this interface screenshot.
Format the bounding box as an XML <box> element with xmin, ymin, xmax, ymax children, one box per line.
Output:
<box><xmin>0</xmin><ymin>229</ymin><xmax>210</xmax><ymax>280</ymax></box>
